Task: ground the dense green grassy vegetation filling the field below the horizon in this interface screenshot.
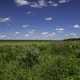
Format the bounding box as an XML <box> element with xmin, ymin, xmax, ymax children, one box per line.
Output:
<box><xmin>0</xmin><ymin>40</ymin><xmax>80</xmax><ymax>80</ymax></box>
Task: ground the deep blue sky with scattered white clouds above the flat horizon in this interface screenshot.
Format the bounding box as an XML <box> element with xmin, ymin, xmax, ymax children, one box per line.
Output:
<box><xmin>0</xmin><ymin>0</ymin><xmax>80</xmax><ymax>39</ymax></box>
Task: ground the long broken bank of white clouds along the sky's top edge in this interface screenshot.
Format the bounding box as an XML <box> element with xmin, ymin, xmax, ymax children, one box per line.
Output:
<box><xmin>15</xmin><ymin>0</ymin><xmax>71</xmax><ymax>8</ymax></box>
